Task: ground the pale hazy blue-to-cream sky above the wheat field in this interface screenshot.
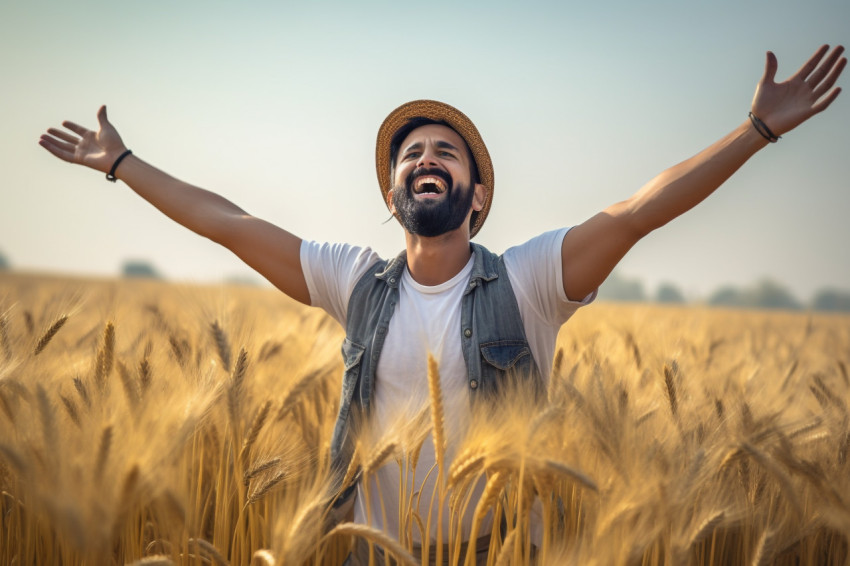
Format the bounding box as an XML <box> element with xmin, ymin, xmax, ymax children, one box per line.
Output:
<box><xmin>0</xmin><ymin>0</ymin><xmax>850</xmax><ymax>300</ymax></box>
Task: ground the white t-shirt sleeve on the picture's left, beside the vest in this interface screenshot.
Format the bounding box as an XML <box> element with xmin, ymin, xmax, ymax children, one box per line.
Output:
<box><xmin>301</xmin><ymin>240</ymin><xmax>380</xmax><ymax>326</ymax></box>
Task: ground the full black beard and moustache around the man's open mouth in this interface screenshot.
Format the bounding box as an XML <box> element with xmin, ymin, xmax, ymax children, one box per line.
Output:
<box><xmin>393</xmin><ymin>168</ymin><xmax>473</xmax><ymax>238</ymax></box>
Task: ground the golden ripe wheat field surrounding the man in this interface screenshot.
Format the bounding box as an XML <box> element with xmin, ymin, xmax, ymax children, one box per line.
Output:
<box><xmin>0</xmin><ymin>273</ymin><xmax>850</xmax><ymax>565</ymax></box>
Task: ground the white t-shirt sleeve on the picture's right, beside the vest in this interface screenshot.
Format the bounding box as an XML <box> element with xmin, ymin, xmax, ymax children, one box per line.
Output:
<box><xmin>504</xmin><ymin>228</ymin><xmax>596</xmax><ymax>327</ymax></box>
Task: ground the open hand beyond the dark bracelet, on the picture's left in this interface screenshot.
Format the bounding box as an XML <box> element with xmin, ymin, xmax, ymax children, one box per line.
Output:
<box><xmin>38</xmin><ymin>106</ymin><xmax>127</xmax><ymax>173</ymax></box>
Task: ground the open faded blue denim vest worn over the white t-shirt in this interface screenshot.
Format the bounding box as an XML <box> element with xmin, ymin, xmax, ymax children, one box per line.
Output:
<box><xmin>331</xmin><ymin>243</ymin><xmax>542</xmax><ymax>499</ymax></box>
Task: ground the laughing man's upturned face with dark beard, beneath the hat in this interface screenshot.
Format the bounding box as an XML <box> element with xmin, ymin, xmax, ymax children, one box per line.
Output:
<box><xmin>392</xmin><ymin>124</ymin><xmax>474</xmax><ymax>238</ymax></box>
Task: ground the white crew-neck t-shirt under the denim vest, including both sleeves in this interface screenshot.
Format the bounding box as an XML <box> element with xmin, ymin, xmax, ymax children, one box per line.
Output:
<box><xmin>301</xmin><ymin>228</ymin><xmax>596</xmax><ymax>542</ymax></box>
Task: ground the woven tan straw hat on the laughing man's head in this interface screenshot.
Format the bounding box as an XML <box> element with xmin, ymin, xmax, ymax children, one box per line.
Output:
<box><xmin>375</xmin><ymin>100</ymin><xmax>494</xmax><ymax>238</ymax></box>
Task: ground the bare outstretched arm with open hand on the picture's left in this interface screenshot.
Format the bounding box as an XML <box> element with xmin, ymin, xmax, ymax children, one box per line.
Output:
<box><xmin>39</xmin><ymin>106</ymin><xmax>310</xmax><ymax>305</ymax></box>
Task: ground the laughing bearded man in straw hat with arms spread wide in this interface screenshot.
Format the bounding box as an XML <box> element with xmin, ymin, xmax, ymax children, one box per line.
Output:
<box><xmin>40</xmin><ymin>46</ymin><xmax>847</xmax><ymax>560</ymax></box>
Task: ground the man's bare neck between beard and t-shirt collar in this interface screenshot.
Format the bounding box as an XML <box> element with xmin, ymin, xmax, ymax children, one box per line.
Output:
<box><xmin>405</xmin><ymin>230</ymin><xmax>472</xmax><ymax>287</ymax></box>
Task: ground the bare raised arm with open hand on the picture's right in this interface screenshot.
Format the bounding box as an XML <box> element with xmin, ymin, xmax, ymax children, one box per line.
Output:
<box><xmin>561</xmin><ymin>45</ymin><xmax>847</xmax><ymax>300</ymax></box>
